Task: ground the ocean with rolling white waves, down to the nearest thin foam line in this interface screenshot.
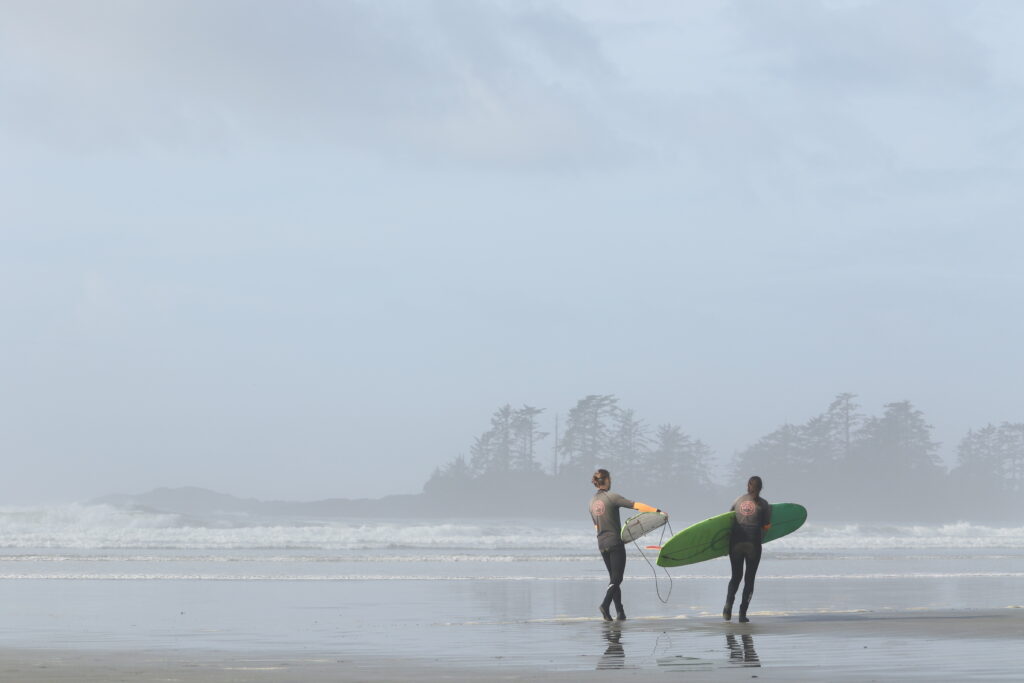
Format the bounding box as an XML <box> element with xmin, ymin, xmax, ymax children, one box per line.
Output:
<box><xmin>0</xmin><ymin>505</ymin><xmax>1024</xmax><ymax>582</ymax></box>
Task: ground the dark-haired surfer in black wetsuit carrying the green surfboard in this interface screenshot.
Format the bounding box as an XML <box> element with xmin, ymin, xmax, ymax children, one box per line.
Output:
<box><xmin>722</xmin><ymin>476</ymin><xmax>771</xmax><ymax>624</ymax></box>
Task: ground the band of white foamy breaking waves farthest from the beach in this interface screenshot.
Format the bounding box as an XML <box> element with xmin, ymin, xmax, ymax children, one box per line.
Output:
<box><xmin>0</xmin><ymin>505</ymin><xmax>1024</xmax><ymax>562</ymax></box>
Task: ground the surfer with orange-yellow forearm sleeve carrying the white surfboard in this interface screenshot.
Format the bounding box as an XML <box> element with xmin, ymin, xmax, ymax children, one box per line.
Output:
<box><xmin>590</xmin><ymin>470</ymin><xmax>668</xmax><ymax>622</ymax></box>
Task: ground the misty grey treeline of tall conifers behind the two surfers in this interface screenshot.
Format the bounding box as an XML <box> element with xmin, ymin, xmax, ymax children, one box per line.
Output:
<box><xmin>424</xmin><ymin>393</ymin><xmax>1024</xmax><ymax>523</ymax></box>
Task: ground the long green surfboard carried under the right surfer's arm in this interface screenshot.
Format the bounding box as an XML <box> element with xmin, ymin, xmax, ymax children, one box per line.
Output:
<box><xmin>657</xmin><ymin>503</ymin><xmax>807</xmax><ymax>567</ymax></box>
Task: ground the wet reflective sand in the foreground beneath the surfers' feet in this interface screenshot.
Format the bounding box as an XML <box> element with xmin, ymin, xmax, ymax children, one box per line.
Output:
<box><xmin>0</xmin><ymin>607</ymin><xmax>1024</xmax><ymax>683</ymax></box>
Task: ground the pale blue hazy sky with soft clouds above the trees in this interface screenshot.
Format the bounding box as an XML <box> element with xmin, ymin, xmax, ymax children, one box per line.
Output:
<box><xmin>0</xmin><ymin>0</ymin><xmax>1024</xmax><ymax>504</ymax></box>
